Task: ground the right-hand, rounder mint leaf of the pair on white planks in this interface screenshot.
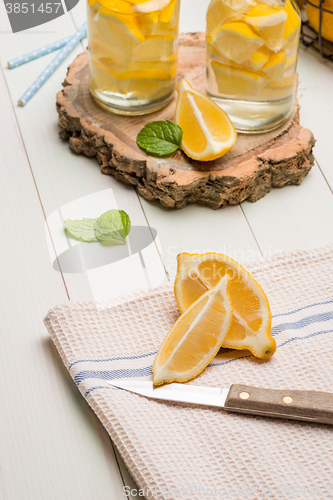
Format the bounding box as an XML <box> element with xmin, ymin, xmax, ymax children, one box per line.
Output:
<box><xmin>95</xmin><ymin>210</ymin><xmax>131</xmax><ymax>243</ymax></box>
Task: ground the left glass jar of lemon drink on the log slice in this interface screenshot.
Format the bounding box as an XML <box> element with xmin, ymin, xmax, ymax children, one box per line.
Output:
<box><xmin>87</xmin><ymin>0</ymin><xmax>180</xmax><ymax>115</ymax></box>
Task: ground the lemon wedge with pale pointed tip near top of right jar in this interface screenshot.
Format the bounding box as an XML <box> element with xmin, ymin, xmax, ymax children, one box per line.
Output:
<box><xmin>245</xmin><ymin>3</ymin><xmax>287</xmax><ymax>51</ymax></box>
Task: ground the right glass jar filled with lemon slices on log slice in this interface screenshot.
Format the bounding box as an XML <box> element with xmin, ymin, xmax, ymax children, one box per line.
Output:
<box><xmin>207</xmin><ymin>0</ymin><xmax>301</xmax><ymax>133</ymax></box>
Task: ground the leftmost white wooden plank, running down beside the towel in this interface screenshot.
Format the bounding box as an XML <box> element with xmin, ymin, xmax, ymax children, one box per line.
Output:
<box><xmin>0</xmin><ymin>64</ymin><xmax>122</xmax><ymax>500</ymax></box>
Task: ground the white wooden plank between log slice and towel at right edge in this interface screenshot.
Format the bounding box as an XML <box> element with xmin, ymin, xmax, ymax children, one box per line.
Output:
<box><xmin>242</xmin><ymin>161</ymin><xmax>333</xmax><ymax>254</ymax></box>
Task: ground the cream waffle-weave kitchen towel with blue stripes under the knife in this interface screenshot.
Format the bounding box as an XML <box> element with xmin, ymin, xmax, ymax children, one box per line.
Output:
<box><xmin>45</xmin><ymin>245</ymin><xmax>333</xmax><ymax>500</ymax></box>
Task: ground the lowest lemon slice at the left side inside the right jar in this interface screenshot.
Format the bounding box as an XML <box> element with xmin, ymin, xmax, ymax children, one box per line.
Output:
<box><xmin>212</xmin><ymin>61</ymin><xmax>268</xmax><ymax>99</ymax></box>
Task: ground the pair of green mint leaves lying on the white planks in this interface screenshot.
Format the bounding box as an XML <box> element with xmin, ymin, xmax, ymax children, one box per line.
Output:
<box><xmin>65</xmin><ymin>210</ymin><xmax>131</xmax><ymax>244</ymax></box>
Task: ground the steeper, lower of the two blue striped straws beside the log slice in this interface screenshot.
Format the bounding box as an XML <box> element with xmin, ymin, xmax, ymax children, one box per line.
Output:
<box><xmin>18</xmin><ymin>23</ymin><xmax>87</xmax><ymax>106</ymax></box>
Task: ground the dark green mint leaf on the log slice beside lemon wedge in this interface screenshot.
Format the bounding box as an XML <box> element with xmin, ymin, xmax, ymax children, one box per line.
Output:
<box><xmin>136</xmin><ymin>120</ymin><xmax>183</xmax><ymax>156</ymax></box>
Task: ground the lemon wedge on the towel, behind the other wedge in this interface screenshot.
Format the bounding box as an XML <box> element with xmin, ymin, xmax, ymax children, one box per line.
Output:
<box><xmin>175</xmin><ymin>253</ymin><xmax>276</xmax><ymax>358</ymax></box>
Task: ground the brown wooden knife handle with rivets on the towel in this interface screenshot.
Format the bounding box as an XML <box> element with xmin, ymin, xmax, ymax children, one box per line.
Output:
<box><xmin>225</xmin><ymin>384</ymin><xmax>333</xmax><ymax>424</ymax></box>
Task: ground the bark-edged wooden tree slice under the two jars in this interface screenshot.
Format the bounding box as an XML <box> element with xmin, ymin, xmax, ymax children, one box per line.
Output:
<box><xmin>57</xmin><ymin>33</ymin><xmax>315</xmax><ymax>208</ymax></box>
